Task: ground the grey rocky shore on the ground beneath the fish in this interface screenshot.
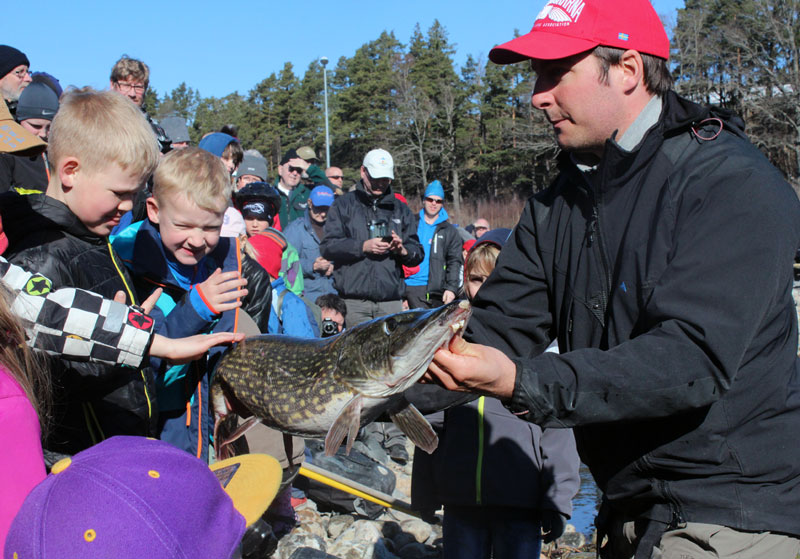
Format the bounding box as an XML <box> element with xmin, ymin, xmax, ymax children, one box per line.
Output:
<box><xmin>272</xmin><ymin>442</ymin><xmax>595</xmax><ymax>559</ymax></box>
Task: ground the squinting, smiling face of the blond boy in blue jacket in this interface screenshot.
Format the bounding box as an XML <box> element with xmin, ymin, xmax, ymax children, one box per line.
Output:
<box><xmin>147</xmin><ymin>193</ymin><xmax>226</xmax><ymax>266</ymax></box>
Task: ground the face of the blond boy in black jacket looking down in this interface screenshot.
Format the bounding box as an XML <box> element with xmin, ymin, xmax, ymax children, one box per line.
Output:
<box><xmin>47</xmin><ymin>157</ymin><xmax>143</xmax><ymax>237</ymax></box>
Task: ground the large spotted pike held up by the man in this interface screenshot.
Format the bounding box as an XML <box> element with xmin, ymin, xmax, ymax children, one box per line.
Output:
<box><xmin>213</xmin><ymin>301</ymin><xmax>472</xmax><ymax>455</ymax></box>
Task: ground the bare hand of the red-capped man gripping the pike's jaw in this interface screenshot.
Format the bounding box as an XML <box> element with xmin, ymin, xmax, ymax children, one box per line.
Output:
<box><xmin>422</xmin><ymin>336</ymin><xmax>517</xmax><ymax>400</ymax></box>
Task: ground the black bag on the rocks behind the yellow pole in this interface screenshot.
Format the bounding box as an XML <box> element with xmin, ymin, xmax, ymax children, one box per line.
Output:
<box><xmin>294</xmin><ymin>439</ymin><xmax>396</xmax><ymax>520</ymax></box>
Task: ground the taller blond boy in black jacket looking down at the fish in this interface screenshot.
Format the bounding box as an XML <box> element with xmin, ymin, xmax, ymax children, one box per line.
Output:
<box><xmin>0</xmin><ymin>88</ymin><xmax>158</xmax><ymax>454</ymax></box>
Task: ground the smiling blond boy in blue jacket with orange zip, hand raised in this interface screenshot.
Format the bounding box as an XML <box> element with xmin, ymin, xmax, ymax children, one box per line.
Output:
<box><xmin>114</xmin><ymin>147</ymin><xmax>269</xmax><ymax>459</ymax></box>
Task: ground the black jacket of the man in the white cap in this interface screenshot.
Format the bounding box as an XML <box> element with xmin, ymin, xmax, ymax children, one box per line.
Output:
<box><xmin>319</xmin><ymin>181</ymin><xmax>423</xmax><ymax>301</ymax></box>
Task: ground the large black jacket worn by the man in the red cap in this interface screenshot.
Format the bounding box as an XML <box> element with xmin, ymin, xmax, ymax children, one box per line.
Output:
<box><xmin>469</xmin><ymin>93</ymin><xmax>800</xmax><ymax>536</ymax></box>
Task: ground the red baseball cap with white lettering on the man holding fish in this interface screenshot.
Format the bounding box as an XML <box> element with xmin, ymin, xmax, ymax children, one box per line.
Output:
<box><xmin>489</xmin><ymin>0</ymin><xmax>669</xmax><ymax>64</ymax></box>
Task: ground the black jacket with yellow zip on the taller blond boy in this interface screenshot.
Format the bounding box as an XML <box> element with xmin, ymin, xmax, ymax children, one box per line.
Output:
<box><xmin>0</xmin><ymin>192</ymin><xmax>157</xmax><ymax>454</ymax></box>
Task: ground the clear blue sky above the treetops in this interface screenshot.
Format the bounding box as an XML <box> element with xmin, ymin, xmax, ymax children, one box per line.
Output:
<box><xmin>0</xmin><ymin>0</ymin><xmax>683</xmax><ymax>97</ymax></box>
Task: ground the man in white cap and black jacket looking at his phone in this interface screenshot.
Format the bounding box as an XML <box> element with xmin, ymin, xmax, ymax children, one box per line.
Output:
<box><xmin>320</xmin><ymin>149</ymin><xmax>423</xmax><ymax>326</ymax></box>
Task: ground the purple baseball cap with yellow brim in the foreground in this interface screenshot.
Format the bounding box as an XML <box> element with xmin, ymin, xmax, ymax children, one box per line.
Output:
<box><xmin>4</xmin><ymin>437</ymin><xmax>281</xmax><ymax>559</ymax></box>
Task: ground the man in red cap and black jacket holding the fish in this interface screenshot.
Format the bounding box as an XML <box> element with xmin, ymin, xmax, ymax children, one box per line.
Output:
<box><xmin>427</xmin><ymin>0</ymin><xmax>800</xmax><ymax>559</ymax></box>
